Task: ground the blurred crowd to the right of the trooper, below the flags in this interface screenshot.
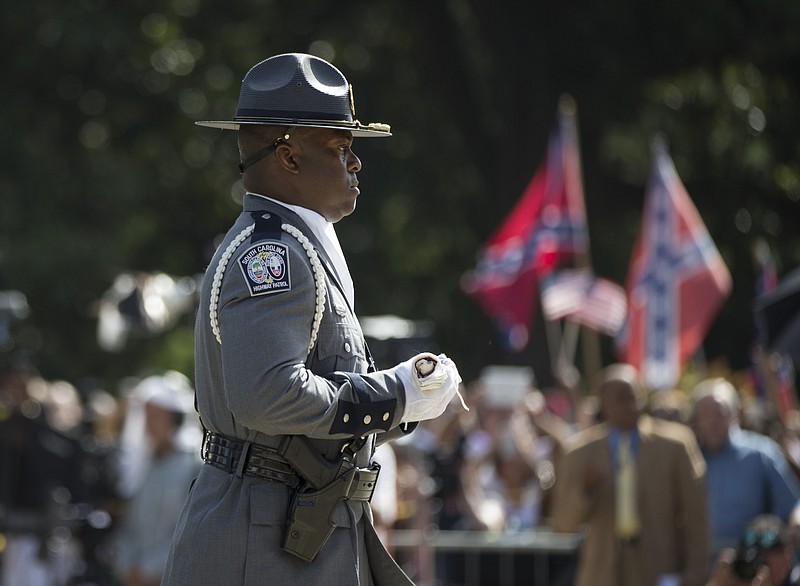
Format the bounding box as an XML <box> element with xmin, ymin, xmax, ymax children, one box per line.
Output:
<box><xmin>378</xmin><ymin>358</ymin><xmax>800</xmax><ymax>586</ymax></box>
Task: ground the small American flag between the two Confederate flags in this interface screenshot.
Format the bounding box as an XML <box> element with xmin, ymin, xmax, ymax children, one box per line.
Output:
<box><xmin>542</xmin><ymin>269</ymin><xmax>628</xmax><ymax>336</ymax></box>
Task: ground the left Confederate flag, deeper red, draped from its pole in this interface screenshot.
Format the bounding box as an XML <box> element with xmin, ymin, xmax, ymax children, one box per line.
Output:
<box><xmin>461</xmin><ymin>100</ymin><xmax>587</xmax><ymax>351</ymax></box>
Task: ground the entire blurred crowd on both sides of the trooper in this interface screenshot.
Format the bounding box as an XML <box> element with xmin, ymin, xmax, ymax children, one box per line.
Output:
<box><xmin>0</xmin><ymin>354</ymin><xmax>800</xmax><ymax>586</ymax></box>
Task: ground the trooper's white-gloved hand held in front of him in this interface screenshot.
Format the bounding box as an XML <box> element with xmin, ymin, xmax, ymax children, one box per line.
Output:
<box><xmin>394</xmin><ymin>352</ymin><xmax>461</xmax><ymax>423</ymax></box>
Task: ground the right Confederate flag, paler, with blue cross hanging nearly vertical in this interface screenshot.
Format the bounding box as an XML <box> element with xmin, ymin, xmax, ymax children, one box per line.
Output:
<box><xmin>617</xmin><ymin>141</ymin><xmax>731</xmax><ymax>389</ymax></box>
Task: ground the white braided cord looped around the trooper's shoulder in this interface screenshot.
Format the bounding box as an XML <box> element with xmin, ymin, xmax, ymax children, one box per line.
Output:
<box><xmin>208</xmin><ymin>224</ymin><xmax>326</xmax><ymax>354</ymax></box>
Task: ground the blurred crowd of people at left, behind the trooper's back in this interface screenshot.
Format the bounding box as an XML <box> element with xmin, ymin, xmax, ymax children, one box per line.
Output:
<box><xmin>0</xmin><ymin>362</ymin><xmax>201</xmax><ymax>586</ymax></box>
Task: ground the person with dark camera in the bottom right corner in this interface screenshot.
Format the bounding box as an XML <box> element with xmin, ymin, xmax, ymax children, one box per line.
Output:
<box><xmin>708</xmin><ymin>515</ymin><xmax>800</xmax><ymax>586</ymax></box>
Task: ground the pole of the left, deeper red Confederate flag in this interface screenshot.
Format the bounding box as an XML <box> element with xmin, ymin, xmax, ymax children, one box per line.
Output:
<box><xmin>558</xmin><ymin>94</ymin><xmax>601</xmax><ymax>389</ymax></box>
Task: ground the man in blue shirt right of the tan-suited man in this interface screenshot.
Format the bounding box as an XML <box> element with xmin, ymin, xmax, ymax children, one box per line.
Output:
<box><xmin>693</xmin><ymin>378</ymin><xmax>800</xmax><ymax>559</ymax></box>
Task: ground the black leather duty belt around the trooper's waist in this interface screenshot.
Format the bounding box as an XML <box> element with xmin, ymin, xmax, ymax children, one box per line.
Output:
<box><xmin>202</xmin><ymin>431</ymin><xmax>380</xmax><ymax>502</ymax></box>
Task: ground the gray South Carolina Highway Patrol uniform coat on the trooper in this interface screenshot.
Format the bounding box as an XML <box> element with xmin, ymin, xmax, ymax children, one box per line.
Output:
<box><xmin>162</xmin><ymin>194</ymin><xmax>411</xmax><ymax>586</ymax></box>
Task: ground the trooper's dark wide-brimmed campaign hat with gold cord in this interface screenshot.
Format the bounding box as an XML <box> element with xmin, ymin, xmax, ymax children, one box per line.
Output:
<box><xmin>195</xmin><ymin>53</ymin><xmax>391</xmax><ymax>137</ymax></box>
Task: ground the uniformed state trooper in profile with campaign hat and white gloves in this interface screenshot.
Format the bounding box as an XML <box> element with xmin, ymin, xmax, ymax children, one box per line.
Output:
<box><xmin>163</xmin><ymin>53</ymin><xmax>461</xmax><ymax>586</ymax></box>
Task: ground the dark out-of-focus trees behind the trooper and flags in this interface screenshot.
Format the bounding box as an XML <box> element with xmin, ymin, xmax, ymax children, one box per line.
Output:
<box><xmin>0</xmin><ymin>0</ymin><xmax>800</xmax><ymax>393</ymax></box>
